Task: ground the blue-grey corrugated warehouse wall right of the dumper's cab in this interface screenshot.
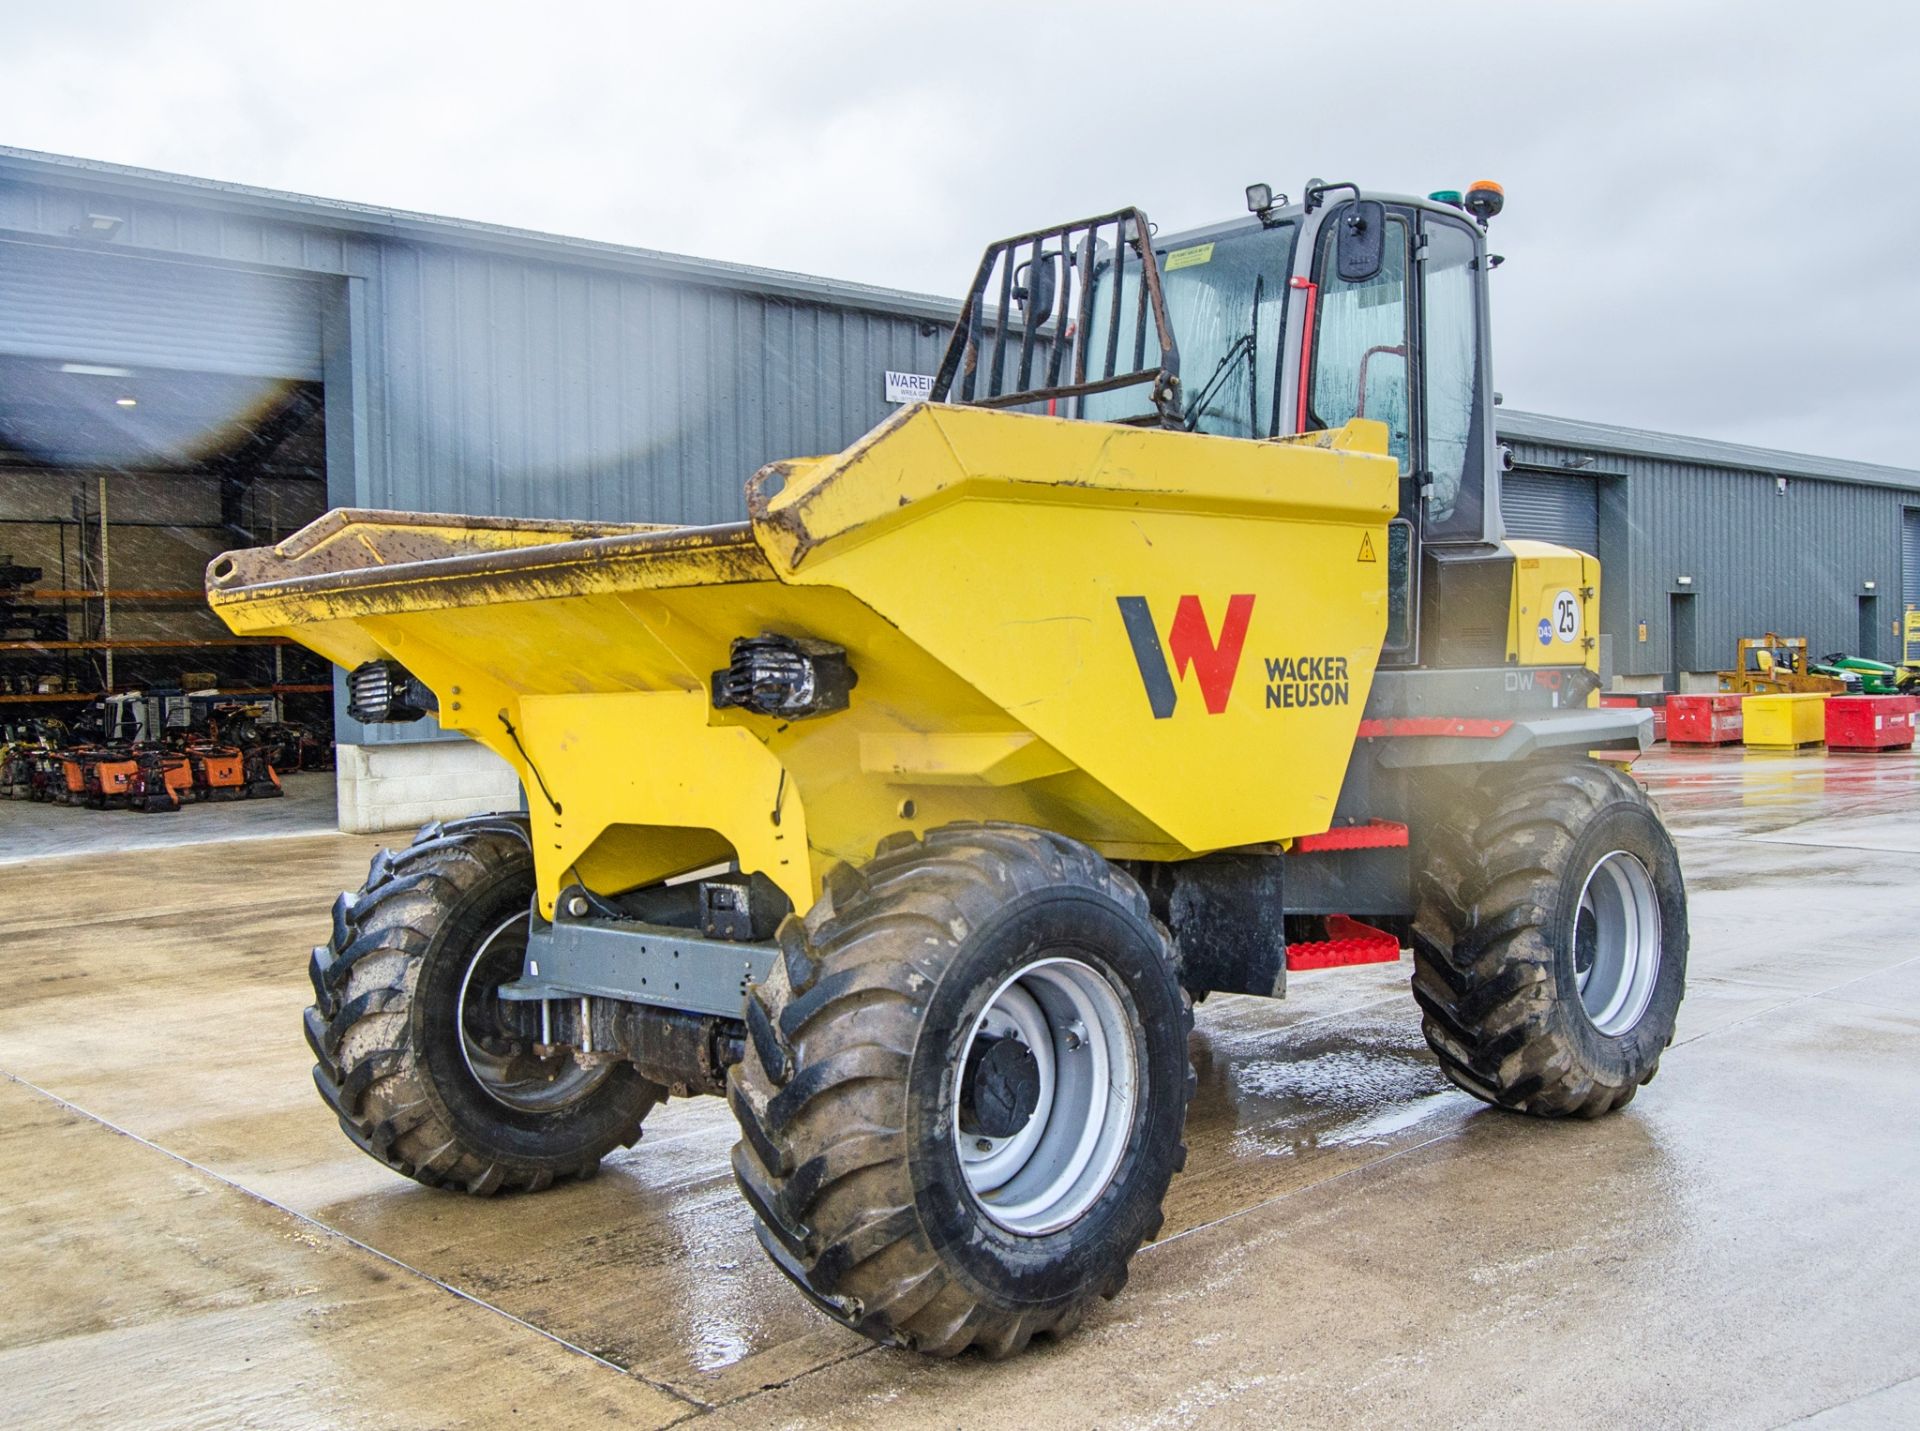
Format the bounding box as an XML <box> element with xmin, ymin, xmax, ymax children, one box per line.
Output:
<box><xmin>1511</xmin><ymin>432</ymin><xmax>1914</xmax><ymax>676</ymax></box>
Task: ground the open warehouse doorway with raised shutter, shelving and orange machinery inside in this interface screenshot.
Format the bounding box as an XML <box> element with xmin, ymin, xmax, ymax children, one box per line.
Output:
<box><xmin>0</xmin><ymin>242</ymin><xmax>332</xmax><ymax>837</ymax></box>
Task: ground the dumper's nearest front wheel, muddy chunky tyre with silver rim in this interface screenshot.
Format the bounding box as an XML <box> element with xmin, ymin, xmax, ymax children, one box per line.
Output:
<box><xmin>728</xmin><ymin>824</ymin><xmax>1194</xmax><ymax>1356</ymax></box>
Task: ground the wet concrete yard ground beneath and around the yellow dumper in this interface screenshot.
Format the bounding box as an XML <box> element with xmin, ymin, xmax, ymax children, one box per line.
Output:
<box><xmin>0</xmin><ymin>751</ymin><xmax>1920</xmax><ymax>1427</ymax></box>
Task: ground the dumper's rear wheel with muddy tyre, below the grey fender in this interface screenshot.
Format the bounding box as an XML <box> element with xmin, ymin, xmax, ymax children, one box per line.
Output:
<box><xmin>1413</xmin><ymin>759</ymin><xmax>1688</xmax><ymax>1118</ymax></box>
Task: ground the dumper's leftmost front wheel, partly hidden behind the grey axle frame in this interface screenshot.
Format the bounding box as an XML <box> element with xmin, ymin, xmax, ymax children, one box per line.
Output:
<box><xmin>305</xmin><ymin>814</ymin><xmax>664</xmax><ymax>1195</ymax></box>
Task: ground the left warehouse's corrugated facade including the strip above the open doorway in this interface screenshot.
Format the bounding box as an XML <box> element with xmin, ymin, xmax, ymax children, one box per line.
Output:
<box><xmin>0</xmin><ymin>160</ymin><xmax>964</xmax><ymax>522</ymax></box>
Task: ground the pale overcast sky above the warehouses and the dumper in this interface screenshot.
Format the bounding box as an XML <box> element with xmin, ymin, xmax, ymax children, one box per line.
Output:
<box><xmin>0</xmin><ymin>0</ymin><xmax>1920</xmax><ymax>467</ymax></box>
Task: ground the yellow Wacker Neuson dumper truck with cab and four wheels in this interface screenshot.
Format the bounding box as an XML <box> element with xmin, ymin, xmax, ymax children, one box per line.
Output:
<box><xmin>207</xmin><ymin>182</ymin><xmax>1688</xmax><ymax>1354</ymax></box>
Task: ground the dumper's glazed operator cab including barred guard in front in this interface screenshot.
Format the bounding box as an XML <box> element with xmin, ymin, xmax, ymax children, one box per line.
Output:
<box><xmin>933</xmin><ymin>181</ymin><xmax>1503</xmax><ymax>665</ymax></box>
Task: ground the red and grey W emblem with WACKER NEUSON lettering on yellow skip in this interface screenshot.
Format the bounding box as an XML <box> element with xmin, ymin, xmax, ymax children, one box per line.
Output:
<box><xmin>1116</xmin><ymin>594</ymin><xmax>1352</xmax><ymax>720</ymax></box>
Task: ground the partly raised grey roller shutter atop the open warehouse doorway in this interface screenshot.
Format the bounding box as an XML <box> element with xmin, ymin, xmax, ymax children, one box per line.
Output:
<box><xmin>0</xmin><ymin>242</ymin><xmax>321</xmax><ymax>380</ymax></box>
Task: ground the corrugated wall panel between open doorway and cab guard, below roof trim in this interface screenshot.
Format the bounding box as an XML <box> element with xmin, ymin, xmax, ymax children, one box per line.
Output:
<box><xmin>365</xmin><ymin>246</ymin><xmax>945</xmax><ymax>522</ymax></box>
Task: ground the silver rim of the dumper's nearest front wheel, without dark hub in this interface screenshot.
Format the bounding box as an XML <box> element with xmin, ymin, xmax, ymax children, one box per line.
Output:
<box><xmin>952</xmin><ymin>958</ymin><xmax>1140</xmax><ymax>1237</ymax></box>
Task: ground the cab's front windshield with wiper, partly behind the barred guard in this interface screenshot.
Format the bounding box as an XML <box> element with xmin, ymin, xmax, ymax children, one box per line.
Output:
<box><xmin>1081</xmin><ymin>223</ymin><xmax>1294</xmax><ymax>438</ymax></box>
